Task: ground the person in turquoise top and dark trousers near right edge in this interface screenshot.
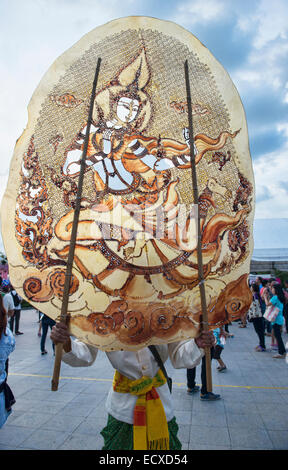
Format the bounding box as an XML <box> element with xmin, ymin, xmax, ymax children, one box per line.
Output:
<box><xmin>268</xmin><ymin>283</ymin><xmax>286</xmax><ymax>359</ymax></box>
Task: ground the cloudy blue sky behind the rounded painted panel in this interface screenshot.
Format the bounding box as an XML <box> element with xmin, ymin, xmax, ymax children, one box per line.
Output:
<box><xmin>0</xmin><ymin>0</ymin><xmax>288</xmax><ymax>250</ymax></box>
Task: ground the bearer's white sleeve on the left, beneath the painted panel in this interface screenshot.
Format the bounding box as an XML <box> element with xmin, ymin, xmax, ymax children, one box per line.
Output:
<box><xmin>62</xmin><ymin>338</ymin><xmax>98</xmax><ymax>367</ymax></box>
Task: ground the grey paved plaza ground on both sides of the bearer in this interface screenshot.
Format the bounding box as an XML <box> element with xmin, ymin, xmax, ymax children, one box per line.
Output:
<box><xmin>0</xmin><ymin>310</ymin><xmax>288</xmax><ymax>450</ymax></box>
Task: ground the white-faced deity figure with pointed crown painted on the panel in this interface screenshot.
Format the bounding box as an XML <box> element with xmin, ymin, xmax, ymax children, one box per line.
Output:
<box><xmin>56</xmin><ymin>49</ymin><xmax>243</xmax><ymax>268</ymax></box>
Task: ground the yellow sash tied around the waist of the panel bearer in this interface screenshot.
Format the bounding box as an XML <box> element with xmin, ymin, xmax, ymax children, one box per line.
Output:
<box><xmin>113</xmin><ymin>369</ymin><xmax>169</xmax><ymax>450</ymax></box>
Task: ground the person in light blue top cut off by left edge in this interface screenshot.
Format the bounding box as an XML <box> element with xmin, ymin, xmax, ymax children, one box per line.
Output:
<box><xmin>0</xmin><ymin>295</ymin><xmax>15</xmax><ymax>428</ymax></box>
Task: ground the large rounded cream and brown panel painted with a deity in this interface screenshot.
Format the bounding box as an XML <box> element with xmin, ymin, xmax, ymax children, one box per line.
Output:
<box><xmin>1</xmin><ymin>17</ymin><xmax>254</xmax><ymax>350</ymax></box>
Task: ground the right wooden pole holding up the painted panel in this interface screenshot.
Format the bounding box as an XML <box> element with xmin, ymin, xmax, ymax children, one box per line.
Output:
<box><xmin>184</xmin><ymin>60</ymin><xmax>212</xmax><ymax>392</ymax></box>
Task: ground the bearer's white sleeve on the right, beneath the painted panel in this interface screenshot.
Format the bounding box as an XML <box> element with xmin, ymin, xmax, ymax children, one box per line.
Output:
<box><xmin>168</xmin><ymin>339</ymin><xmax>205</xmax><ymax>369</ymax></box>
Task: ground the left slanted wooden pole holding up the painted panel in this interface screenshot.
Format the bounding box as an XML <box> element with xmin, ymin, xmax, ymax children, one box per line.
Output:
<box><xmin>51</xmin><ymin>57</ymin><xmax>101</xmax><ymax>392</ymax></box>
